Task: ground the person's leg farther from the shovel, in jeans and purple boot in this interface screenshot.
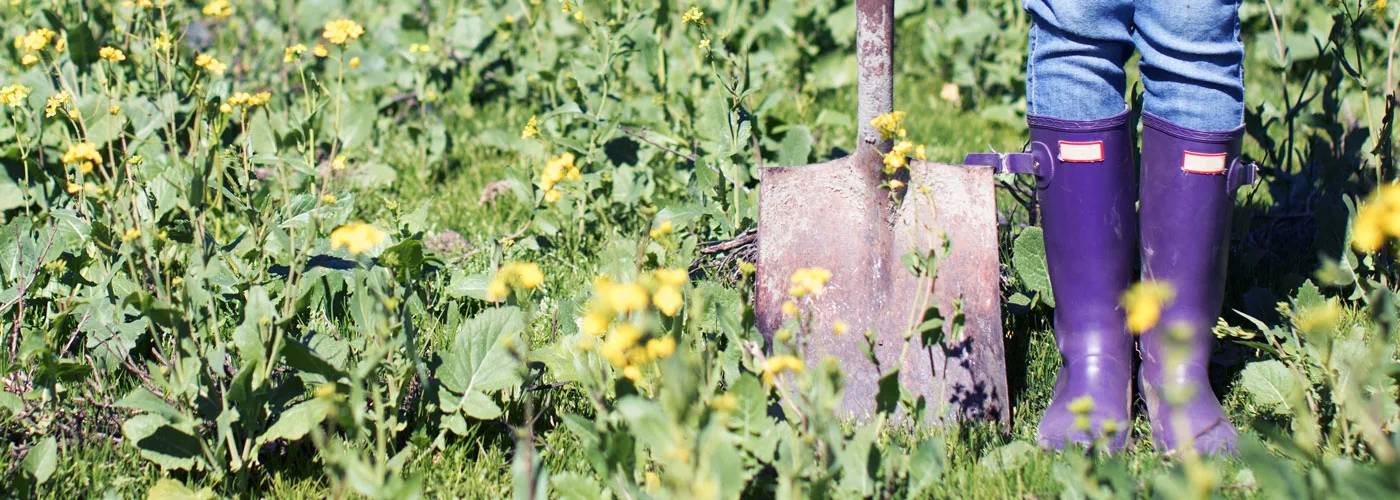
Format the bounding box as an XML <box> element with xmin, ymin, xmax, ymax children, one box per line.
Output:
<box><xmin>1134</xmin><ymin>0</ymin><xmax>1245</xmax><ymax>452</ymax></box>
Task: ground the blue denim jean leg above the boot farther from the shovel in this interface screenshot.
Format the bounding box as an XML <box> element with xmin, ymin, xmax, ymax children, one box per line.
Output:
<box><xmin>1133</xmin><ymin>0</ymin><xmax>1245</xmax><ymax>132</ymax></box>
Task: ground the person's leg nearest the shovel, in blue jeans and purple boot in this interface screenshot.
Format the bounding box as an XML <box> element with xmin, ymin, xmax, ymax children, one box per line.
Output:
<box><xmin>1026</xmin><ymin>0</ymin><xmax>1137</xmax><ymax>450</ymax></box>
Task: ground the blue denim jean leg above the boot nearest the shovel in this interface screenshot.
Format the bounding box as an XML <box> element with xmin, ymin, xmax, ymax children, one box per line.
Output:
<box><xmin>1025</xmin><ymin>0</ymin><xmax>1133</xmax><ymax>120</ymax></box>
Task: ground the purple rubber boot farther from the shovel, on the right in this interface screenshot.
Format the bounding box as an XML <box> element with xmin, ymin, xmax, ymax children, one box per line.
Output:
<box><xmin>1138</xmin><ymin>113</ymin><xmax>1254</xmax><ymax>454</ymax></box>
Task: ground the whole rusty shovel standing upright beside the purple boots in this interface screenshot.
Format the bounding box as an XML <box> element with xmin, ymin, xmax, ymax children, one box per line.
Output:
<box><xmin>755</xmin><ymin>0</ymin><xmax>1021</xmax><ymax>430</ymax></box>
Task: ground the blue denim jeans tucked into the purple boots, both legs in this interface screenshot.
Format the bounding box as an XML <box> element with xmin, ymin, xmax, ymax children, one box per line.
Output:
<box><xmin>1025</xmin><ymin>0</ymin><xmax>1245</xmax><ymax>132</ymax></box>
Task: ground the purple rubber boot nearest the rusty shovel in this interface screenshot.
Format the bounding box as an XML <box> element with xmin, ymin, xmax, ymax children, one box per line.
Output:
<box><xmin>1028</xmin><ymin>112</ymin><xmax>1138</xmax><ymax>451</ymax></box>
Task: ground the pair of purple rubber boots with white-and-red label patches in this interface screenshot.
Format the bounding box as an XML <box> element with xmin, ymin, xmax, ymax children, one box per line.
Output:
<box><xmin>1028</xmin><ymin>112</ymin><xmax>1254</xmax><ymax>454</ymax></box>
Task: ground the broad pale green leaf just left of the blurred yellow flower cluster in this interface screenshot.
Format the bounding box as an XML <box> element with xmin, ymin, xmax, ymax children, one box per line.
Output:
<box><xmin>438</xmin><ymin>307</ymin><xmax>525</xmax><ymax>419</ymax></box>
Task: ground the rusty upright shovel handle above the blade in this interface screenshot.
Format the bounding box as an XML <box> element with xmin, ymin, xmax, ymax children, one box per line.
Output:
<box><xmin>855</xmin><ymin>0</ymin><xmax>895</xmax><ymax>153</ymax></box>
